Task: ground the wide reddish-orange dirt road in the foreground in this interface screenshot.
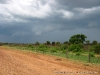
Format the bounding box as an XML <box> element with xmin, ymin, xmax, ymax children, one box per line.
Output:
<box><xmin>0</xmin><ymin>47</ymin><xmax>100</xmax><ymax>75</ymax></box>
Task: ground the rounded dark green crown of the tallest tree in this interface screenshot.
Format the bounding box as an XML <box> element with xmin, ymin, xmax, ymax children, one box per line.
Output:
<box><xmin>69</xmin><ymin>34</ymin><xmax>87</xmax><ymax>44</ymax></box>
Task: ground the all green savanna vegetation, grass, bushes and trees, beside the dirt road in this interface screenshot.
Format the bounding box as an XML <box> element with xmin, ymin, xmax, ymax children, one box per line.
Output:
<box><xmin>0</xmin><ymin>34</ymin><xmax>100</xmax><ymax>64</ymax></box>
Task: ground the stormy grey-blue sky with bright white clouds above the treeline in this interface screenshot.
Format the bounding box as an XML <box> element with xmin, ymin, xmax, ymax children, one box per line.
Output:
<box><xmin>0</xmin><ymin>0</ymin><xmax>100</xmax><ymax>43</ymax></box>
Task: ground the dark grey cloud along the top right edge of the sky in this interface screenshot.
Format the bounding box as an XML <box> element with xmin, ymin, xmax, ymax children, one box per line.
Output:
<box><xmin>57</xmin><ymin>0</ymin><xmax>100</xmax><ymax>8</ymax></box>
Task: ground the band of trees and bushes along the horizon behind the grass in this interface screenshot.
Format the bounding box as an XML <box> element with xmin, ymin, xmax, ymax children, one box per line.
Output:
<box><xmin>0</xmin><ymin>34</ymin><xmax>100</xmax><ymax>54</ymax></box>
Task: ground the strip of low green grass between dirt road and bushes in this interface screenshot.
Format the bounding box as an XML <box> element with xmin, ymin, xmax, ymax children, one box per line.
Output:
<box><xmin>3</xmin><ymin>46</ymin><xmax>100</xmax><ymax>65</ymax></box>
